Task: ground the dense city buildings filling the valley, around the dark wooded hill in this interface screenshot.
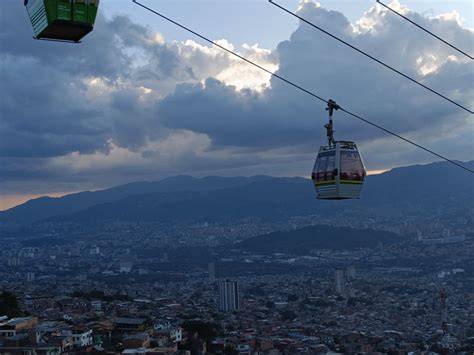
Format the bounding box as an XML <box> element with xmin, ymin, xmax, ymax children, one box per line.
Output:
<box><xmin>0</xmin><ymin>211</ymin><xmax>474</xmax><ymax>354</ymax></box>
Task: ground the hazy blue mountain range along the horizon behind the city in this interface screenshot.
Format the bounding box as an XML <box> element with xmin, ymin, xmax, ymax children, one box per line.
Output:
<box><xmin>0</xmin><ymin>161</ymin><xmax>474</xmax><ymax>231</ymax></box>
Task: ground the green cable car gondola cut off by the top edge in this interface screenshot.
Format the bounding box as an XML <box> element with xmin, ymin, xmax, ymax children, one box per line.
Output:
<box><xmin>25</xmin><ymin>0</ymin><xmax>99</xmax><ymax>42</ymax></box>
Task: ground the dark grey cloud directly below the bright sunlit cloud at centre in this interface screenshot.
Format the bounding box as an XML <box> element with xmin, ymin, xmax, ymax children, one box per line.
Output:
<box><xmin>160</xmin><ymin>79</ymin><xmax>303</xmax><ymax>147</ymax></box>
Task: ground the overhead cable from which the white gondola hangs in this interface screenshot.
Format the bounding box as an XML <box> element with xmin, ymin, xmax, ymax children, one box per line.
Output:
<box><xmin>132</xmin><ymin>0</ymin><xmax>474</xmax><ymax>174</ymax></box>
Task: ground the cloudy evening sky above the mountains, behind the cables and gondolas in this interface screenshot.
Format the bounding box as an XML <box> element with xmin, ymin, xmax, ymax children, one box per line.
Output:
<box><xmin>0</xmin><ymin>0</ymin><xmax>474</xmax><ymax>209</ymax></box>
